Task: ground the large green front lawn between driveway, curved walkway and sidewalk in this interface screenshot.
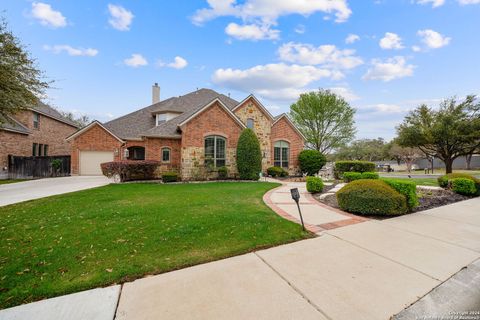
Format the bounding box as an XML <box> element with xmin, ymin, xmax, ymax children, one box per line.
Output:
<box><xmin>0</xmin><ymin>182</ymin><xmax>311</xmax><ymax>309</ymax></box>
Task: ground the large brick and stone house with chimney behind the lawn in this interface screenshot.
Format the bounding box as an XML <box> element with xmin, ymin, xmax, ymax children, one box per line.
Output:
<box><xmin>67</xmin><ymin>84</ymin><xmax>304</xmax><ymax>180</ymax></box>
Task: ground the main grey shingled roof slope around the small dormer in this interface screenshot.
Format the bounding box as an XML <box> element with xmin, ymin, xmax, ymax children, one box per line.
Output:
<box><xmin>104</xmin><ymin>89</ymin><xmax>238</xmax><ymax>139</ymax></box>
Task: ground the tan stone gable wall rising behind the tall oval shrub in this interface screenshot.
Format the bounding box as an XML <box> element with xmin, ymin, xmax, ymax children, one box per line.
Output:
<box><xmin>235</xmin><ymin>98</ymin><xmax>273</xmax><ymax>171</ymax></box>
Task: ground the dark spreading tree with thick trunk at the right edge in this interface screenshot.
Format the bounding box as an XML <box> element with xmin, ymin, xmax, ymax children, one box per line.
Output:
<box><xmin>397</xmin><ymin>95</ymin><xmax>480</xmax><ymax>173</ymax></box>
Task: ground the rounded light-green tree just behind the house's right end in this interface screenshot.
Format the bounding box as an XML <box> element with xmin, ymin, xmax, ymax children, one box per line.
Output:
<box><xmin>290</xmin><ymin>89</ymin><xmax>356</xmax><ymax>154</ymax></box>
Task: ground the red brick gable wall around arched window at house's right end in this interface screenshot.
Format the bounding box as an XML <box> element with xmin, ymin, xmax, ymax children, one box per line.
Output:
<box><xmin>271</xmin><ymin>117</ymin><xmax>304</xmax><ymax>175</ymax></box>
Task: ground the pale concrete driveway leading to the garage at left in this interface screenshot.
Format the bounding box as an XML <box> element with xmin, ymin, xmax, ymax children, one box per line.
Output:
<box><xmin>0</xmin><ymin>176</ymin><xmax>111</xmax><ymax>207</ymax></box>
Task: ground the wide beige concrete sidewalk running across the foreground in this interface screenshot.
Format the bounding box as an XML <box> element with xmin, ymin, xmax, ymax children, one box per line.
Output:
<box><xmin>0</xmin><ymin>198</ymin><xmax>480</xmax><ymax>320</ymax></box>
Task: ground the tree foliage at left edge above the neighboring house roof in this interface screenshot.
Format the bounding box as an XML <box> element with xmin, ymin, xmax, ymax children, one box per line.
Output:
<box><xmin>0</xmin><ymin>18</ymin><xmax>49</xmax><ymax>123</ymax></box>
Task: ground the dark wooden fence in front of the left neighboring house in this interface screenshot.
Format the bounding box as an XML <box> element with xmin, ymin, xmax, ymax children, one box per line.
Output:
<box><xmin>8</xmin><ymin>155</ymin><xmax>70</xmax><ymax>179</ymax></box>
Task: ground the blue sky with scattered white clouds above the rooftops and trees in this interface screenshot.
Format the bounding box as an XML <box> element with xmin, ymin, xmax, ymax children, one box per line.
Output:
<box><xmin>0</xmin><ymin>0</ymin><xmax>480</xmax><ymax>139</ymax></box>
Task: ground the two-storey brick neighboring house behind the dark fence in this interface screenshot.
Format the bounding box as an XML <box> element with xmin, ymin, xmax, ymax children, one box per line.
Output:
<box><xmin>0</xmin><ymin>103</ymin><xmax>78</xmax><ymax>178</ymax></box>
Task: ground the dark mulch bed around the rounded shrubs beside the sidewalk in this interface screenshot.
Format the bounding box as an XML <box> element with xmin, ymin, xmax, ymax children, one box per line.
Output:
<box><xmin>312</xmin><ymin>185</ymin><xmax>471</xmax><ymax>220</ymax></box>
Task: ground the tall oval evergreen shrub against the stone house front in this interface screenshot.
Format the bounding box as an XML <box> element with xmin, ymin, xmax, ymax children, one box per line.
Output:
<box><xmin>237</xmin><ymin>128</ymin><xmax>262</xmax><ymax>180</ymax></box>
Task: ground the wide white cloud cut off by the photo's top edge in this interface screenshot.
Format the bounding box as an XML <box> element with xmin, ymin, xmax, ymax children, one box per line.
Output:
<box><xmin>192</xmin><ymin>0</ymin><xmax>352</xmax><ymax>25</ymax></box>
